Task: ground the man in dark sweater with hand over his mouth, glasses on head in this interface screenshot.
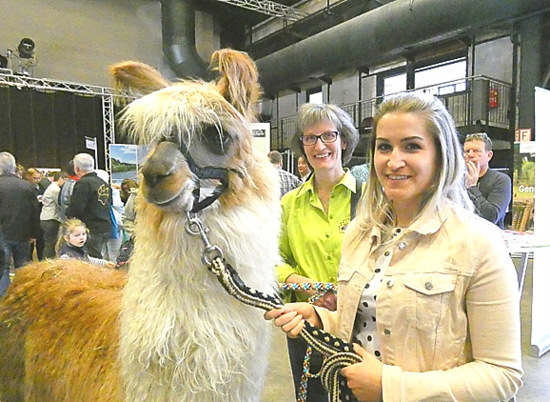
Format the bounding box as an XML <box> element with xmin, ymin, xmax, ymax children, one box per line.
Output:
<box><xmin>464</xmin><ymin>133</ymin><xmax>512</xmax><ymax>229</ymax></box>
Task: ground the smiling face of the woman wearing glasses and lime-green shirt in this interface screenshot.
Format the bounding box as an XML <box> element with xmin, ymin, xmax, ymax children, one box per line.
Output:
<box><xmin>303</xmin><ymin>121</ymin><xmax>346</xmax><ymax>175</ymax></box>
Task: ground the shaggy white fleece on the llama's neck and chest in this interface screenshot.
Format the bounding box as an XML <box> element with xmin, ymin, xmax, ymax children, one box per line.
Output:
<box><xmin>120</xmin><ymin>181</ymin><xmax>280</xmax><ymax>402</ymax></box>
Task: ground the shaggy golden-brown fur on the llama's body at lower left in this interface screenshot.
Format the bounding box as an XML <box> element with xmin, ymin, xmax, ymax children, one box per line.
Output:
<box><xmin>0</xmin><ymin>259</ymin><xmax>126</xmax><ymax>402</ymax></box>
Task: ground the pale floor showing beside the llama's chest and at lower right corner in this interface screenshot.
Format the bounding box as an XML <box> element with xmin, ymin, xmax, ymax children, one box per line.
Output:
<box><xmin>261</xmin><ymin>261</ymin><xmax>550</xmax><ymax>402</ymax></box>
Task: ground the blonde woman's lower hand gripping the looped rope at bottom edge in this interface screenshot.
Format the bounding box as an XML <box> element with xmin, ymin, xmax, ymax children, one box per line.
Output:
<box><xmin>340</xmin><ymin>344</ymin><xmax>383</xmax><ymax>402</ymax></box>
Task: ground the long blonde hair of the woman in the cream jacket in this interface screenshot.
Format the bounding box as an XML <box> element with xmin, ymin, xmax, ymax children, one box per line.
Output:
<box><xmin>352</xmin><ymin>93</ymin><xmax>473</xmax><ymax>241</ymax></box>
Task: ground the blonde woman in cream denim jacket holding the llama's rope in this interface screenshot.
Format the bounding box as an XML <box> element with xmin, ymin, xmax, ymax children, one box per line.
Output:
<box><xmin>265</xmin><ymin>94</ymin><xmax>523</xmax><ymax>402</ymax></box>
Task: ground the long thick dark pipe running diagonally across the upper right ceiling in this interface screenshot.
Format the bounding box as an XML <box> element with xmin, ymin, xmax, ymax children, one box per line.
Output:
<box><xmin>256</xmin><ymin>0</ymin><xmax>550</xmax><ymax>95</ymax></box>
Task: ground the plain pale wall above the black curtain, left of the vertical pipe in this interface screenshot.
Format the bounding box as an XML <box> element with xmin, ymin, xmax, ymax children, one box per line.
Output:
<box><xmin>0</xmin><ymin>0</ymin><xmax>164</xmax><ymax>86</ymax></box>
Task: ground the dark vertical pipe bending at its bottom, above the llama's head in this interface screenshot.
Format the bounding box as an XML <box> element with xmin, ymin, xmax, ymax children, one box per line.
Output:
<box><xmin>160</xmin><ymin>0</ymin><xmax>213</xmax><ymax>80</ymax></box>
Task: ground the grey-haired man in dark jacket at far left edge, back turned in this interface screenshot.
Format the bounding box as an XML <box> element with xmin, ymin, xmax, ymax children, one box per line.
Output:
<box><xmin>0</xmin><ymin>152</ymin><xmax>40</xmax><ymax>297</ymax></box>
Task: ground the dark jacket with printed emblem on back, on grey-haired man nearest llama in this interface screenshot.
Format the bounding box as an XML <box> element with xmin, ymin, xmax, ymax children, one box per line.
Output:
<box><xmin>66</xmin><ymin>172</ymin><xmax>112</xmax><ymax>233</ymax></box>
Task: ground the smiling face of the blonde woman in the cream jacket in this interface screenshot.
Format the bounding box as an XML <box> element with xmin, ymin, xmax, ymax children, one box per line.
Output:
<box><xmin>374</xmin><ymin>112</ymin><xmax>437</xmax><ymax>226</ymax></box>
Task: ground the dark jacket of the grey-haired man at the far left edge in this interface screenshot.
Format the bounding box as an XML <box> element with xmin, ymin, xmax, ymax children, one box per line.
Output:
<box><xmin>0</xmin><ymin>175</ymin><xmax>40</xmax><ymax>241</ymax></box>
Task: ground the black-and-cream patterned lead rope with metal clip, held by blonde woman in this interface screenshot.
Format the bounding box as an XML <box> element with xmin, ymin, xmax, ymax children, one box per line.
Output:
<box><xmin>186</xmin><ymin>212</ymin><xmax>361</xmax><ymax>402</ymax></box>
